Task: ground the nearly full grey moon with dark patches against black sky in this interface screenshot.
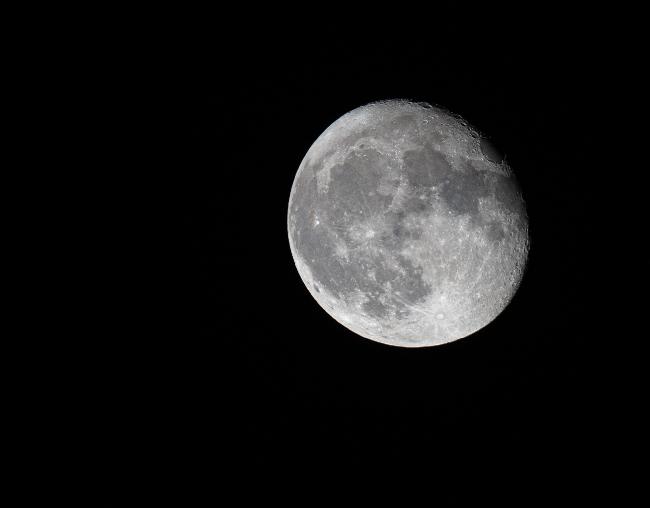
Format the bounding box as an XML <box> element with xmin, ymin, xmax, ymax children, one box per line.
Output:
<box><xmin>287</xmin><ymin>100</ymin><xmax>530</xmax><ymax>347</ymax></box>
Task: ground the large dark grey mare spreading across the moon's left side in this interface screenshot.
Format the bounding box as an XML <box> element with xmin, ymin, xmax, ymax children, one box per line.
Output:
<box><xmin>292</xmin><ymin>143</ymin><xmax>431</xmax><ymax>317</ymax></box>
